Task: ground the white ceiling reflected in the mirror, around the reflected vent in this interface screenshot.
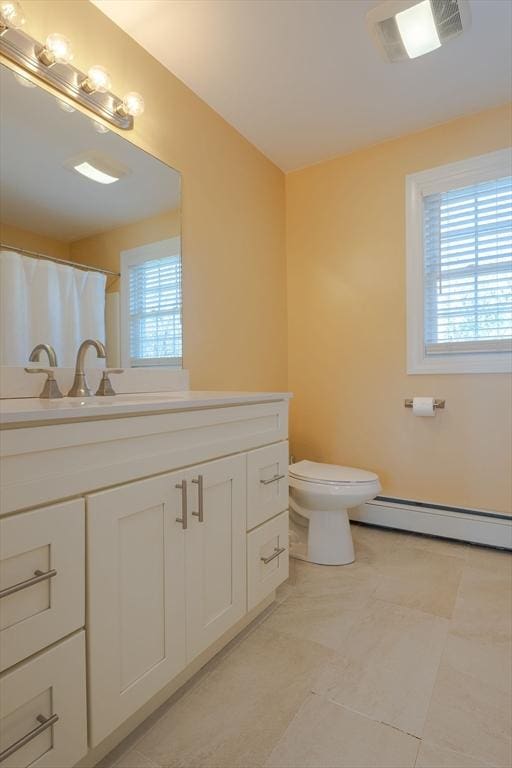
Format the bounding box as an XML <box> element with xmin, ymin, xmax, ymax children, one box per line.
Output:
<box><xmin>0</xmin><ymin>65</ymin><xmax>180</xmax><ymax>242</ymax></box>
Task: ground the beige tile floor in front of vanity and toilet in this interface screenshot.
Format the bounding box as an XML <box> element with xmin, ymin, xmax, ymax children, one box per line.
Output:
<box><xmin>101</xmin><ymin>526</ymin><xmax>512</xmax><ymax>768</ymax></box>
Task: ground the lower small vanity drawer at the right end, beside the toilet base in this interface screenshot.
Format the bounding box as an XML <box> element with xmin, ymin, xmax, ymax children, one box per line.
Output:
<box><xmin>247</xmin><ymin>512</ymin><xmax>288</xmax><ymax>611</ymax></box>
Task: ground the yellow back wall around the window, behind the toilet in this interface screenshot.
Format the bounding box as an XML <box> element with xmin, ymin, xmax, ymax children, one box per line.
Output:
<box><xmin>286</xmin><ymin>100</ymin><xmax>512</xmax><ymax>512</ymax></box>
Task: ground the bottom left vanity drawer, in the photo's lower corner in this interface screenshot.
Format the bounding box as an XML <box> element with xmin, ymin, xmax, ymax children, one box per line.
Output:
<box><xmin>0</xmin><ymin>632</ymin><xmax>87</xmax><ymax>768</ymax></box>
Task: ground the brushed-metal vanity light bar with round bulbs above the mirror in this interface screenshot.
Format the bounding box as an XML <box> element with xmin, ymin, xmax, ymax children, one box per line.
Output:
<box><xmin>0</xmin><ymin>0</ymin><xmax>144</xmax><ymax>130</ymax></box>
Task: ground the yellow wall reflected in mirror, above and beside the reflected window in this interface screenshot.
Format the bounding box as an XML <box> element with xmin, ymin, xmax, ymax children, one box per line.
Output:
<box><xmin>69</xmin><ymin>210</ymin><xmax>180</xmax><ymax>291</ymax></box>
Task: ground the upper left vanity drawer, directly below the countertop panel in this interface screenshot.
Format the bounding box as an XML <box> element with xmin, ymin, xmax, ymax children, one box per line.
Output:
<box><xmin>0</xmin><ymin>499</ymin><xmax>85</xmax><ymax>670</ymax></box>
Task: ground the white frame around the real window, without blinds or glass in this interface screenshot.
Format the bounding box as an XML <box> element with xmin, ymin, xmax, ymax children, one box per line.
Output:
<box><xmin>405</xmin><ymin>148</ymin><xmax>512</xmax><ymax>374</ymax></box>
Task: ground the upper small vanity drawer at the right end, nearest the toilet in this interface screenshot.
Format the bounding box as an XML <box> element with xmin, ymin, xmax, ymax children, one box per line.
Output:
<box><xmin>247</xmin><ymin>441</ymin><xmax>288</xmax><ymax>531</ymax></box>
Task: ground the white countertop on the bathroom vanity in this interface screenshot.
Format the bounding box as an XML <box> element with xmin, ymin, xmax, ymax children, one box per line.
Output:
<box><xmin>0</xmin><ymin>390</ymin><xmax>292</xmax><ymax>429</ymax></box>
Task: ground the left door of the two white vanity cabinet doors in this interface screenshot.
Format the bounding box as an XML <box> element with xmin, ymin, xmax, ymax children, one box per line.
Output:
<box><xmin>87</xmin><ymin>473</ymin><xmax>186</xmax><ymax>746</ymax></box>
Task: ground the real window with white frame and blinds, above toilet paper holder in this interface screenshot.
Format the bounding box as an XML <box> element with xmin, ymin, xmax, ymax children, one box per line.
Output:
<box><xmin>406</xmin><ymin>150</ymin><xmax>512</xmax><ymax>373</ymax></box>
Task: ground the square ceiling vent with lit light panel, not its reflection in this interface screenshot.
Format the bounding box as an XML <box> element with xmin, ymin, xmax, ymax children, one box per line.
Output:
<box><xmin>366</xmin><ymin>0</ymin><xmax>470</xmax><ymax>62</ymax></box>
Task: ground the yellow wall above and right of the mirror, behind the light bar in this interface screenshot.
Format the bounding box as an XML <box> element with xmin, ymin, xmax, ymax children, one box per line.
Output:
<box><xmin>10</xmin><ymin>0</ymin><xmax>287</xmax><ymax>390</ymax></box>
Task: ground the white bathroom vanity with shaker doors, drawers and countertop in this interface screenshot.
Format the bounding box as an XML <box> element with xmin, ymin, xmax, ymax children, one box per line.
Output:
<box><xmin>0</xmin><ymin>392</ymin><xmax>288</xmax><ymax>768</ymax></box>
